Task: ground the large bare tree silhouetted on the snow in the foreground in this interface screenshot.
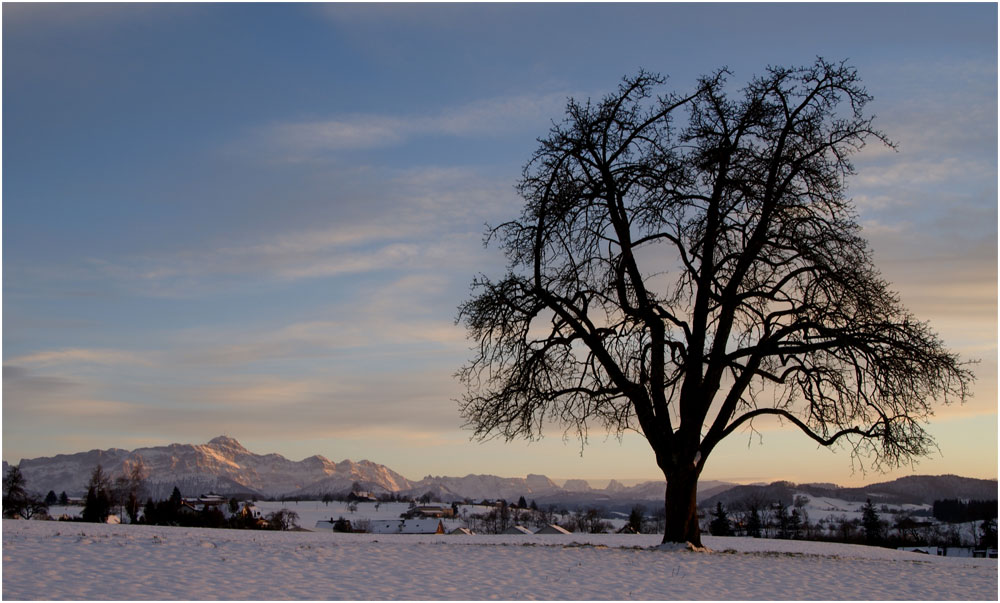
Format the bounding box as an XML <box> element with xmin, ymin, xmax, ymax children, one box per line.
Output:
<box><xmin>459</xmin><ymin>59</ymin><xmax>973</xmax><ymax>544</ymax></box>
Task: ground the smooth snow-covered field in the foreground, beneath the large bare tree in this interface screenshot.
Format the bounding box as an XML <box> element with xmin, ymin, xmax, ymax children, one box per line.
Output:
<box><xmin>2</xmin><ymin>520</ymin><xmax>998</xmax><ymax>600</ymax></box>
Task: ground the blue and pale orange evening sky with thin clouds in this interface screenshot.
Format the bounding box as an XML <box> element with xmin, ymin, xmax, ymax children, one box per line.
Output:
<box><xmin>2</xmin><ymin>3</ymin><xmax>998</xmax><ymax>485</ymax></box>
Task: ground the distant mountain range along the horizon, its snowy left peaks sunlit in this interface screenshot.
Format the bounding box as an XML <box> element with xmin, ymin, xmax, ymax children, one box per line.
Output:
<box><xmin>3</xmin><ymin>436</ymin><xmax>997</xmax><ymax>509</ymax></box>
